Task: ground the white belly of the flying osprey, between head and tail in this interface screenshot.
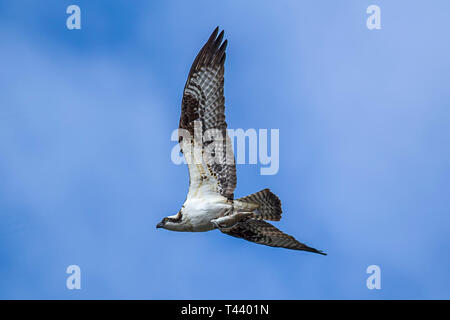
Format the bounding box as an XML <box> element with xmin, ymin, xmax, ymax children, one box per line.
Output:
<box><xmin>183</xmin><ymin>199</ymin><xmax>232</xmax><ymax>232</ymax></box>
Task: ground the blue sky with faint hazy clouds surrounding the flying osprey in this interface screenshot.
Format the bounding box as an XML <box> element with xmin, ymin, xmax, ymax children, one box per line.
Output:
<box><xmin>0</xmin><ymin>0</ymin><xmax>450</xmax><ymax>299</ymax></box>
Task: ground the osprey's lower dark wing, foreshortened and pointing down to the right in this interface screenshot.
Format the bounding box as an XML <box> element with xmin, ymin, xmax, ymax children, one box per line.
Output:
<box><xmin>221</xmin><ymin>219</ymin><xmax>326</xmax><ymax>255</ymax></box>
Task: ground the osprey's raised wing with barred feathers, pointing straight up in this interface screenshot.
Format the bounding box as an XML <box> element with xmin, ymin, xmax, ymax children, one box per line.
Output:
<box><xmin>179</xmin><ymin>28</ymin><xmax>236</xmax><ymax>199</ymax></box>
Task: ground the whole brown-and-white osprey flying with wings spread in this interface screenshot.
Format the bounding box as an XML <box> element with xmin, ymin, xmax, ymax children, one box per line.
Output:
<box><xmin>156</xmin><ymin>28</ymin><xmax>325</xmax><ymax>254</ymax></box>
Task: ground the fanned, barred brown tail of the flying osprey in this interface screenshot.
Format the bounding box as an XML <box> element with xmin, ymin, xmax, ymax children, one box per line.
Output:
<box><xmin>234</xmin><ymin>189</ymin><xmax>282</xmax><ymax>221</ymax></box>
